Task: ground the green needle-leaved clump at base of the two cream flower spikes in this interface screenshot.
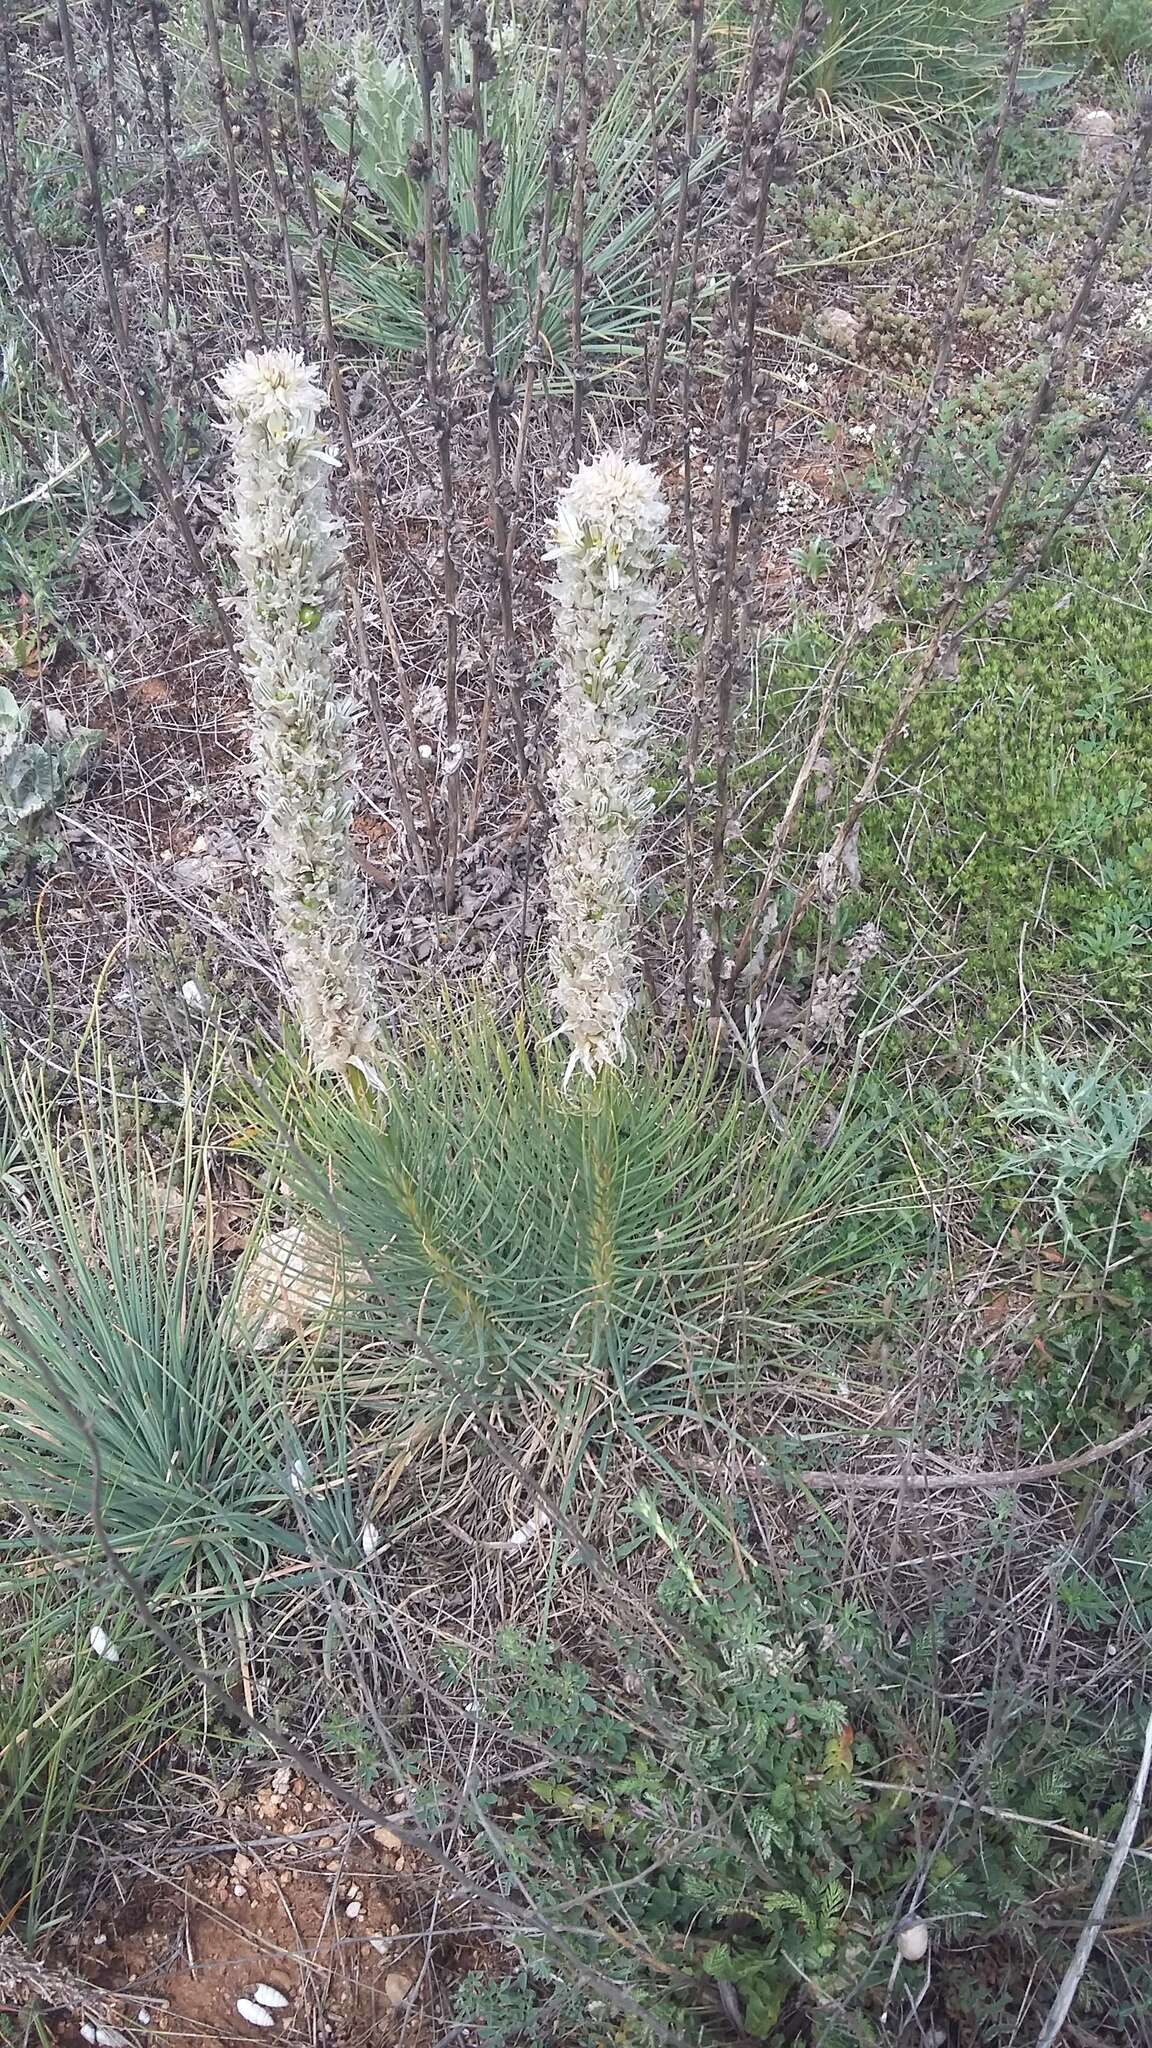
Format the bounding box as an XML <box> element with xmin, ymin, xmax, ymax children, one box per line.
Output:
<box><xmin>254</xmin><ymin>1010</ymin><xmax>912</xmax><ymax>1507</ymax></box>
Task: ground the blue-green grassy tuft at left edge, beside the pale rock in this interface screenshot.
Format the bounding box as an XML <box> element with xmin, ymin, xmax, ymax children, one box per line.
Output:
<box><xmin>0</xmin><ymin>1069</ymin><xmax>363</xmax><ymax>1608</ymax></box>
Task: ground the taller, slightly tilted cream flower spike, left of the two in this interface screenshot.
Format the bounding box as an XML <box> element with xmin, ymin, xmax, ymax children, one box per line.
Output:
<box><xmin>219</xmin><ymin>348</ymin><xmax>379</xmax><ymax>1079</ymax></box>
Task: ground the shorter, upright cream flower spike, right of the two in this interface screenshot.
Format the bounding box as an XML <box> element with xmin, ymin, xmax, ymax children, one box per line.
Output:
<box><xmin>547</xmin><ymin>453</ymin><xmax>668</xmax><ymax>1075</ymax></box>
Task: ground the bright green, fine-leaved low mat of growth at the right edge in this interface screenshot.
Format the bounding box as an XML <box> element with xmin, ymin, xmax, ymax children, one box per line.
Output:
<box><xmin>740</xmin><ymin>526</ymin><xmax>1152</xmax><ymax>1044</ymax></box>
